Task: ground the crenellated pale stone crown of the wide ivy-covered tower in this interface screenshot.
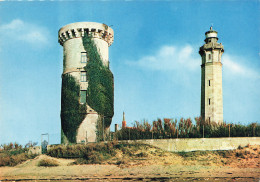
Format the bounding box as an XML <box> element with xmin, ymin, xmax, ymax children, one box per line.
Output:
<box><xmin>58</xmin><ymin>22</ymin><xmax>114</xmax><ymax>46</ymax></box>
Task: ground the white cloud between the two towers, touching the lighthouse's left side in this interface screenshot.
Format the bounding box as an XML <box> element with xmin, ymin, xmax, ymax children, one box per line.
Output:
<box><xmin>127</xmin><ymin>45</ymin><xmax>201</xmax><ymax>71</ymax></box>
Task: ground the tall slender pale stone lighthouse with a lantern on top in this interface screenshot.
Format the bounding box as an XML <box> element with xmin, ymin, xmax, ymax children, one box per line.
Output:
<box><xmin>199</xmin><ymin>27</ymin><xmax>224</xmax><ymax>124</ymax></box>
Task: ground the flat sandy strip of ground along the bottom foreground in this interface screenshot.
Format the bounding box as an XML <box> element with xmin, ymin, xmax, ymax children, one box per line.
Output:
<box><xmin>0</xmin><ymin>162</ymin><xmax>260</xmax><ymax>181</ymax></box>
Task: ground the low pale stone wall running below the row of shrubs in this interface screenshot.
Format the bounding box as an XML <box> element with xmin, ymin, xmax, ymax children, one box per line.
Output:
<box><xmin>128</xmin><ymin>137</ymin><xmax>260</xmax><ymax>152</ymax></box>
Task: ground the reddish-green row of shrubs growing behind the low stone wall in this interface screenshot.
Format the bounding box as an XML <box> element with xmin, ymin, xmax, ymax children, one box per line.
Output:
<box><xmin>114</xmin><ymin>117</ymin><xmax>260</xmax><ymax>140</ymax></box>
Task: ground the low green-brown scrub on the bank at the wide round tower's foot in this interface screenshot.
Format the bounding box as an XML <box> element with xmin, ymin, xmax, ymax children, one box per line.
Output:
<box><xmin>47</xmin><ymin>142</ymin><xmax>149</xmax><ymax>164</ymax></box>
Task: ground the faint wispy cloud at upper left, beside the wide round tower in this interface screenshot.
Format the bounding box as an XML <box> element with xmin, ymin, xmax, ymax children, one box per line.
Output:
<box><xmin>0</xmin><ymin>19</ymin><xmax>49</xmax><ymax>45</ymax></box>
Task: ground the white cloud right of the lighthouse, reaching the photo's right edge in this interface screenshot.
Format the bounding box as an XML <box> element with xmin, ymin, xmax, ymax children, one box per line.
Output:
<box><xmin>222</xmin><ymin>54</ymin><xmax>260</xmax><ymax>78</ymax></box>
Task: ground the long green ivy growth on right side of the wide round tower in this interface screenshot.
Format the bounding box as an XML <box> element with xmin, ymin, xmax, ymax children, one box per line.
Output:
<box><xmin>82</xmin><ymin>33</ymin><xmax>114</xmax><ymax>128</ymax></box>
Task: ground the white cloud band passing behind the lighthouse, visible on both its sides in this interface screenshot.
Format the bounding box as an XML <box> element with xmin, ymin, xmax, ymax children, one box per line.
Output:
<box><xmin>127</xmin><ymin>45</ymin><xmax>260</xmax><ymax>78</ymax></box>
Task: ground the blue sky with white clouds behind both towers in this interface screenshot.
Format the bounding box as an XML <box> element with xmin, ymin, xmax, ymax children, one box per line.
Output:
<box><xmin>0</xmin><ymin>0</ymin><xmax>260</xmax><ymax>144</ymax></box>
